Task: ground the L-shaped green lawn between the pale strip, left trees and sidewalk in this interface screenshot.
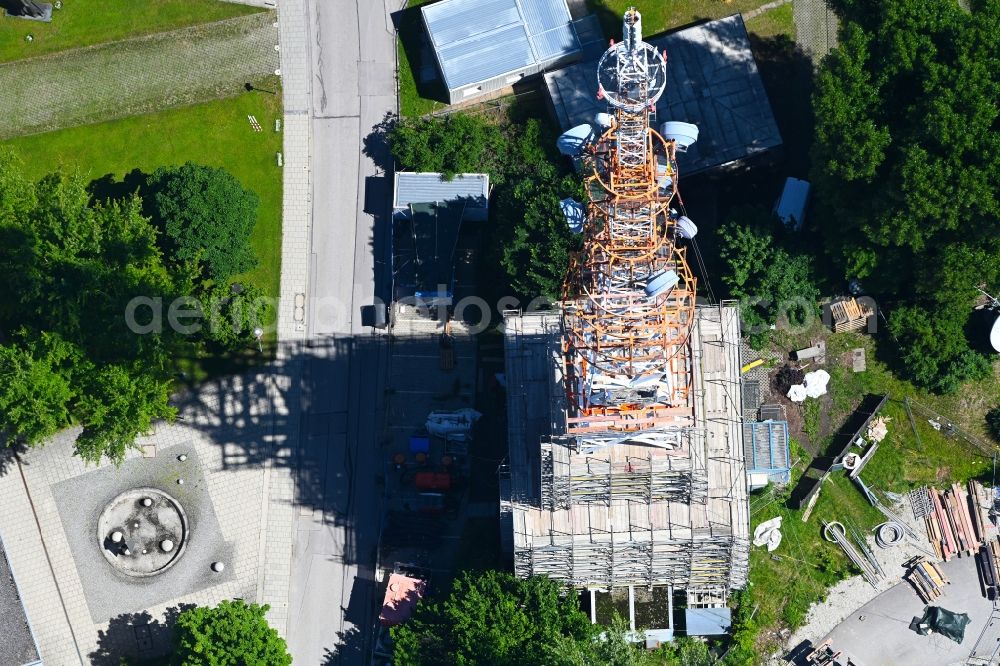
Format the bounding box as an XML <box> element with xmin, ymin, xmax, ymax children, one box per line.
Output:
<box><xmin>4</xmin><ymin>80</ymin><xmax>281</xmax><ymax>296</ymax></box>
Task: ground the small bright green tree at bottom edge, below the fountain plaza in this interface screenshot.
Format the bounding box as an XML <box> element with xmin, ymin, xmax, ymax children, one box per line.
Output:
<box><xmin>169</xmin><ymin>599</ymin><xmax>292</xmax><ymax>666</ymax></box>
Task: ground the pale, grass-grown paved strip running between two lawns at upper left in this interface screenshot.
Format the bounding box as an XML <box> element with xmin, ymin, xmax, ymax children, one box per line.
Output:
<box><xmin>0</xmin><ymin>12</ymin><xmax>278</xmax><ymax>139</ymax></box>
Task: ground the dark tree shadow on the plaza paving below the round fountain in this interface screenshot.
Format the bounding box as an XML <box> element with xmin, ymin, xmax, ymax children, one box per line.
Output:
<box><xmin>87</xmin><ymin>604</ymin><xmax>194</xmax><ymax>666</ymax></box>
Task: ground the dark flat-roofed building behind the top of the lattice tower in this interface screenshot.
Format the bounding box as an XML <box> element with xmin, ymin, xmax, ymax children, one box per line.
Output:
<box><xmin>545</xmin><ymin>14</ymin><xmax>781</xmax><ymax>176</ymax></box>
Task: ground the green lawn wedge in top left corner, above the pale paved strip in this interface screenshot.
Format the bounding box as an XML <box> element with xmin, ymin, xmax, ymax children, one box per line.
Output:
<box><xmin>0</xmin><ymin>0</ymin><xmax>260</xmax><ymax>62</ymax></box>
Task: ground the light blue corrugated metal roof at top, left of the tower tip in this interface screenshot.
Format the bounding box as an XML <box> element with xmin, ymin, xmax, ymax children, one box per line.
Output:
<box><xmin>422</xmin><ymin>0</ymin><xmax>580</xmax><ymax>90</ymax></box>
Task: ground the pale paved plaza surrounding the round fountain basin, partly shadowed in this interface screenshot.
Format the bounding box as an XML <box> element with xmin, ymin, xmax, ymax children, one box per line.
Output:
<box><xmin>0</xmin><ymin>364</ymin><xmax>297</xmax><ymax>665</ymax></box>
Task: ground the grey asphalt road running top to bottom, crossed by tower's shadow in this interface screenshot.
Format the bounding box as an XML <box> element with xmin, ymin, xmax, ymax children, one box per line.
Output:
<box><xmin>288</xmin><ymin>0</ymin><xmax>399</xmax><ymax>665</ymax></box>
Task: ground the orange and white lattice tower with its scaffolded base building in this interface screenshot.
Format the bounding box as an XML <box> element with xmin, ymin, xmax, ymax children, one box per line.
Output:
<box><xmin>500</xmin><ymin>9</ymin><xmax>749</xmax><ymax>639</ymax></box>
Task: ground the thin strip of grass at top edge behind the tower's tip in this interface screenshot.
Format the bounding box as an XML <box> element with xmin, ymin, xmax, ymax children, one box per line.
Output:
<box><xmin>587</xmin><ymin>0</ymin><xmax>767</xmax><ymax>40</ymax></box>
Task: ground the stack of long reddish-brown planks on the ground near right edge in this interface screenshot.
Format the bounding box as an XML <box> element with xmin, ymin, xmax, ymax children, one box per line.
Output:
<box><xmin>924</xmin><ymin>481</ymin><xmax>987</xmax><ymax>562</ymax></box>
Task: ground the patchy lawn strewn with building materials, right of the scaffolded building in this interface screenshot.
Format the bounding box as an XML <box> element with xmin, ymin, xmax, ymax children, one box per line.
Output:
<box><xmin>750</xmin><ymin>326</ymin><xmax>1000</xmax><ymax>650</ymax></box>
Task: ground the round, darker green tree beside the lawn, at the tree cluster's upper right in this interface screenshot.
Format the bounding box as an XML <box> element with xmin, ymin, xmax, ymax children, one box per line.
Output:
<box><xmin>143</xmin><ymin>162</ymin><xmax>260</xmax><ymax>283</ymax></box>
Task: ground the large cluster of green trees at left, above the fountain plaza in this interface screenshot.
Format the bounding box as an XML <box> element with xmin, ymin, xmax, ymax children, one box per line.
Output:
<box><xmin>0</xmin><ymin>150</ymin><xmax>272</xmax><ymax>463</ymax></box>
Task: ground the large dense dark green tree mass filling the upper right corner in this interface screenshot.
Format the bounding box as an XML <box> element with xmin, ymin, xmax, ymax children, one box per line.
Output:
<box><xmin>813</xmin><ymin>0</ymin><xmax>1000</xmax><ymax>391</ymax></box>
